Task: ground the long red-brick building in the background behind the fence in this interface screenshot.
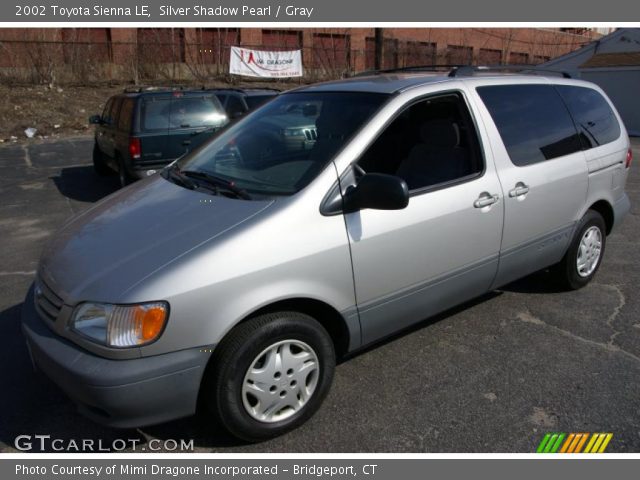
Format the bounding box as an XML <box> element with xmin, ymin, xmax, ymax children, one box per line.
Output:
<box><xmin>0</xmin><ymin>28</ymin><xmax>601</xmax><ymax>80</ymax></box>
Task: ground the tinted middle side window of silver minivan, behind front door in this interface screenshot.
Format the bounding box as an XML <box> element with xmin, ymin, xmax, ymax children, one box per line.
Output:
<box><xmin>477</xmin><ymin>84</ymin><xmax>582</xmax><ymax>167</ymax></box>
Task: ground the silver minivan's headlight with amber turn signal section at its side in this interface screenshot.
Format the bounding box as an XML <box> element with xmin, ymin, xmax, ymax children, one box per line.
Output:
<box><xmin>71</xmin><ymin>302</ymin><xmax>169</xmax><ymax>347</ymax></box>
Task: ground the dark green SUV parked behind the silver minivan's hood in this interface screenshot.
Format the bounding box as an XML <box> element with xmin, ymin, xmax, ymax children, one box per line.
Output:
<box><xmin>89</xmin><ymin>88</ymin><xmax>229</xmax><ymax>186</ymax></box>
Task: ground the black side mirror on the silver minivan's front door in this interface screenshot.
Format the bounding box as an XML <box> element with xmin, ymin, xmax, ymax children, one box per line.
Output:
<box><xmin>344</xmin><ymin>173</ymin><xmax>409</xmax><ymax>213</ymax></box>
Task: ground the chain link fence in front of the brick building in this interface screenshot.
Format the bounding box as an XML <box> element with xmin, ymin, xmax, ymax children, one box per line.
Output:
<box><xmin>0</xmin><ymin>29</ymin><xmax>568</xmax><ymax>85</ymax></box>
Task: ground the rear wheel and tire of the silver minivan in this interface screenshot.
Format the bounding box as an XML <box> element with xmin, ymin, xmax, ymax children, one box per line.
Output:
<box><xmin>553</xmin><ymin>210</ymin><xmax>607</xmax><ymax>290</ymax></box>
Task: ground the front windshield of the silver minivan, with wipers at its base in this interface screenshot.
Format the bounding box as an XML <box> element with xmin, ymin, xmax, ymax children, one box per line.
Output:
<box><xmin>167</xmin><ymin>92</ymin><xmax>388</xmax><ymax>196</ymax></box>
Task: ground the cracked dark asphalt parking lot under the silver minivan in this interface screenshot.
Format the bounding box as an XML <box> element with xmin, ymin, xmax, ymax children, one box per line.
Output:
<box><xmin>0</xmin><ymin>138</ymin><xmax>640</xmax><ymax>452</ymax></box>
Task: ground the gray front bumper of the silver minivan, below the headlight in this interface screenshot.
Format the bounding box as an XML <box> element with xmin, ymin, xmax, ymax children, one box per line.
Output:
<box><xmin>22</xmin><ymin>288</ymin><xmax>211</xmax><ymax>428</ymax></box>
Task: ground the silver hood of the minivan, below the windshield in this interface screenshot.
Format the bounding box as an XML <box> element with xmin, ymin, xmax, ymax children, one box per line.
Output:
<box><xmin>38</xmin><ymin>175</ymin><xmax>273</xmax><ymax>304</ymax></box>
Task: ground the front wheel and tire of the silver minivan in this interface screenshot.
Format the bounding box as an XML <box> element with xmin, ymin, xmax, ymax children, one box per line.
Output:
<box><xmin>203</xmin><ymin>312</ymin><xmax>336</xmax><ymax>442</ymax></box>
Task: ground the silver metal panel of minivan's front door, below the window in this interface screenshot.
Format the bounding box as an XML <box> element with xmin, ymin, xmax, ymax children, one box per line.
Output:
<box><xmin>345</xmin><ymin>169</ymin><xmax>503</xmax><ymax>344</ymax></box>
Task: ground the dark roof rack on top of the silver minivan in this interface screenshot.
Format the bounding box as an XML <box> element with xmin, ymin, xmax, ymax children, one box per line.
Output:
<box><xmin>354</xmin><ymin>64</ymin><xmax>571</xmax><ymax>78</ymax></box>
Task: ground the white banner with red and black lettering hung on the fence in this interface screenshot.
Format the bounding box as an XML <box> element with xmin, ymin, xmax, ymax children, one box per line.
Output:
<box><xmin>229</xmin><ymin>47</ymin><xmax>302</xmax><ymax>78</ymax></box>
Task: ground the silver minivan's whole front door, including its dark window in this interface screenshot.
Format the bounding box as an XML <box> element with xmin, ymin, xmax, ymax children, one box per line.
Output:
<box><xmin>345</xmin><ymin>94</ymin><xmax>503</xmax><ymax>344</ymax></box>
